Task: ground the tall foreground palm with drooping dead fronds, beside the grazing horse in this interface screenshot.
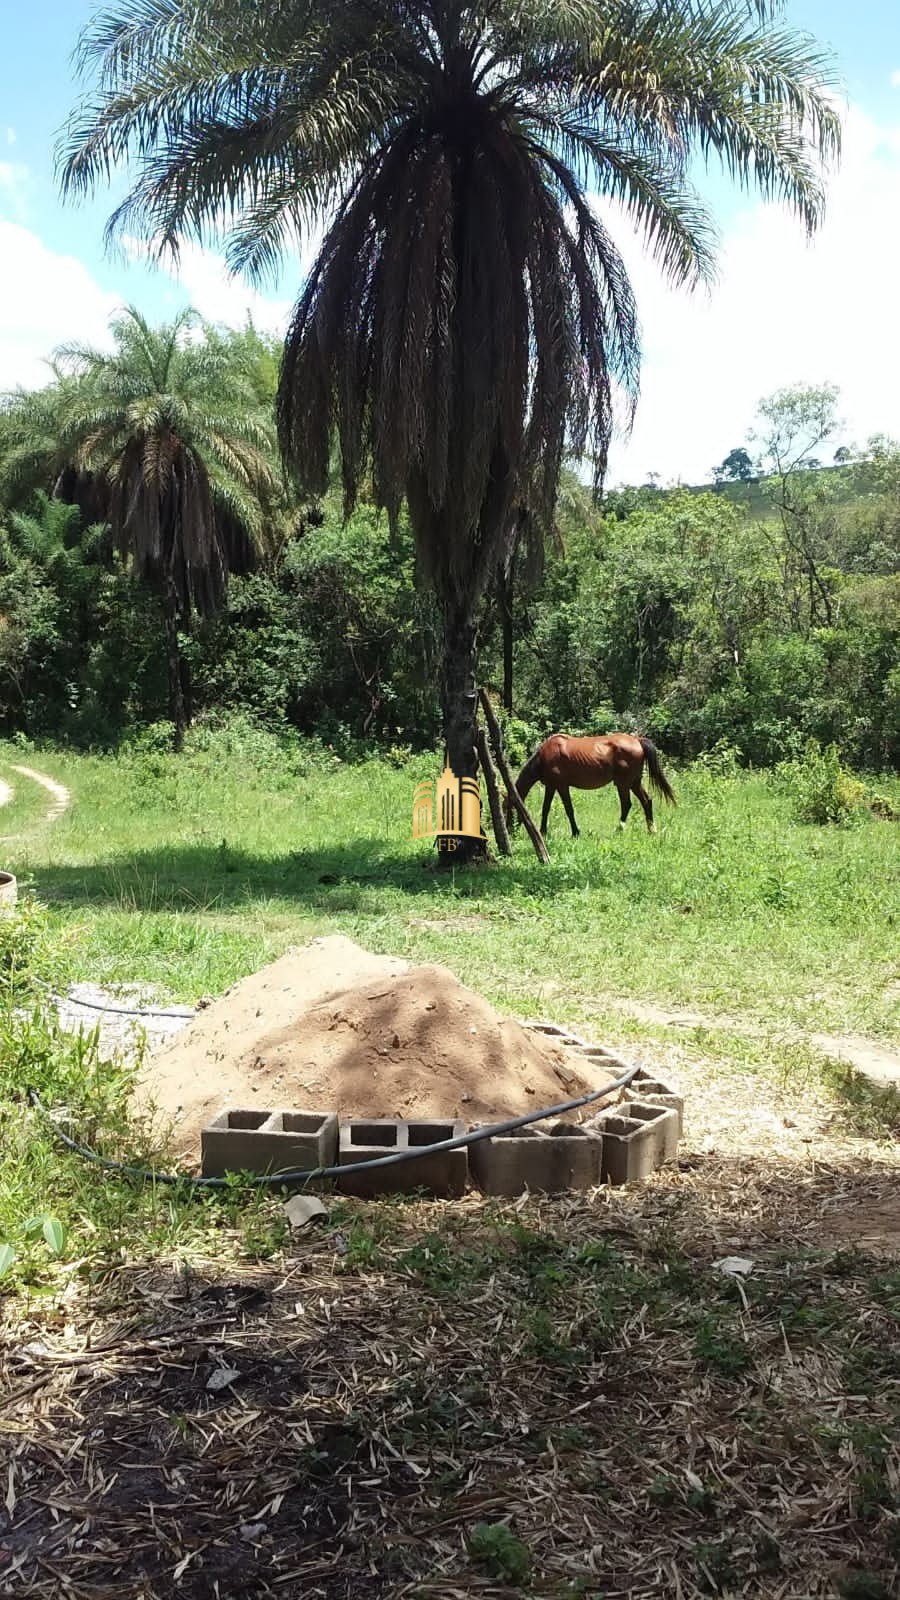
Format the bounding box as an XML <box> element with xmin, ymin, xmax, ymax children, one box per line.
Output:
<box><xmin>61</xmin><ymin>0</ymin><xmax>839</xmax><ymax>825</ymax></box>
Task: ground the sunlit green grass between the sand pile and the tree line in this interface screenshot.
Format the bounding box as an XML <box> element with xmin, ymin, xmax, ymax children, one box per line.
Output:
<box><xmin>0</xmin><ymin>731</ymin><xmax>900</xmax><ymax>1037</ymax></box>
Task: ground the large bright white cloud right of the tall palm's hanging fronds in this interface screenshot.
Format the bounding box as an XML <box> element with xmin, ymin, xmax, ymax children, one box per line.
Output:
<box><xmin>595</xmin><ymin>109</ymin><xmax>900</xmax><ymax>482</ymax></box>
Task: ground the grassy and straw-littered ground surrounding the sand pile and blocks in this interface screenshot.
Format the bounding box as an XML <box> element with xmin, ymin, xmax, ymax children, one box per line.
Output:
<box><xmin>0</xmin><ymin>728</ymin><xmax>900</xmax><ymax>1600</ymax></box>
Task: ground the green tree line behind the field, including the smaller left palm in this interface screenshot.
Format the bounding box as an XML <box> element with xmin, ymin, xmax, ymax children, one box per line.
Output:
<box><xmin>0</xmin><ymin>314</ymin><xmax>900</xmax><ymax>768</ymax></box>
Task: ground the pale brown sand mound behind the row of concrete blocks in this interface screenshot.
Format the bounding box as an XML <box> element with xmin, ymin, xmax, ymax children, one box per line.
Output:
<box><xmin>138</xmin><ymin>938</ymin><xmax>604</xmax><ymax>1158</ymax></box>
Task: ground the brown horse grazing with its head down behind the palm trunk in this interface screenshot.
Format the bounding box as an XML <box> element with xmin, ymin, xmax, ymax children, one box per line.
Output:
<box><xmin>508</xmin><ymin>733</ymin><xmax>676</xmax><ymax>838</ymax></box>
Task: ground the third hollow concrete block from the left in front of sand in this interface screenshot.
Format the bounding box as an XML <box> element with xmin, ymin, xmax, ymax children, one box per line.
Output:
<box><xmin>469</xmin><ymin>1123</ymin><xmax>602</xmax><ymax>1198</ymax></box>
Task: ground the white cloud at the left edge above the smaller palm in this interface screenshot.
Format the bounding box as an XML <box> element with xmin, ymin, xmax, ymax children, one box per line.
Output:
<box><xmin>0</xmin><ymin>219</ymin><xmax>119</xmax><ymax>390</ymax></box>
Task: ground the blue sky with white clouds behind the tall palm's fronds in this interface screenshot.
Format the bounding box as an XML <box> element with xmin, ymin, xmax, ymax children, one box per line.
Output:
<box><xmin>0</xmin><ymin>0</ymin><xmax>900</xmax><ymax>480</ymax></box>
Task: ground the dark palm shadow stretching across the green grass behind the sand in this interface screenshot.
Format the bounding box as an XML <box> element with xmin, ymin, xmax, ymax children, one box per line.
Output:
<box><xmin>34</xmin><ymin>835</ymin><xmax>637</xmax><ymax>910</ymax></box>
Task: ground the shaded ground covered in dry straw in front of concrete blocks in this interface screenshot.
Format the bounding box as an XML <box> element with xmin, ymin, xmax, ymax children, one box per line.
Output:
<box><xmin>0</xmin><ymin>1043</ymin><xmax>900</xmax><ymax>1600</ymax></box>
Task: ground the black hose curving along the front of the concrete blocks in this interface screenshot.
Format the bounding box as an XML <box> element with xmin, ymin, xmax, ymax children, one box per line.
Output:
<box><xmin>27</xmin><ymin>1067</ymin><xmax>639</xmax><ymax>1189</ymax></box>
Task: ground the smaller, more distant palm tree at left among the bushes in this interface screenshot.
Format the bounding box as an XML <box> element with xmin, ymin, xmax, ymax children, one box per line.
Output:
<box><xmin>3</xmin><ymin>309</ymin><xmax>275</xmax><ymax>750</ymax></box>
